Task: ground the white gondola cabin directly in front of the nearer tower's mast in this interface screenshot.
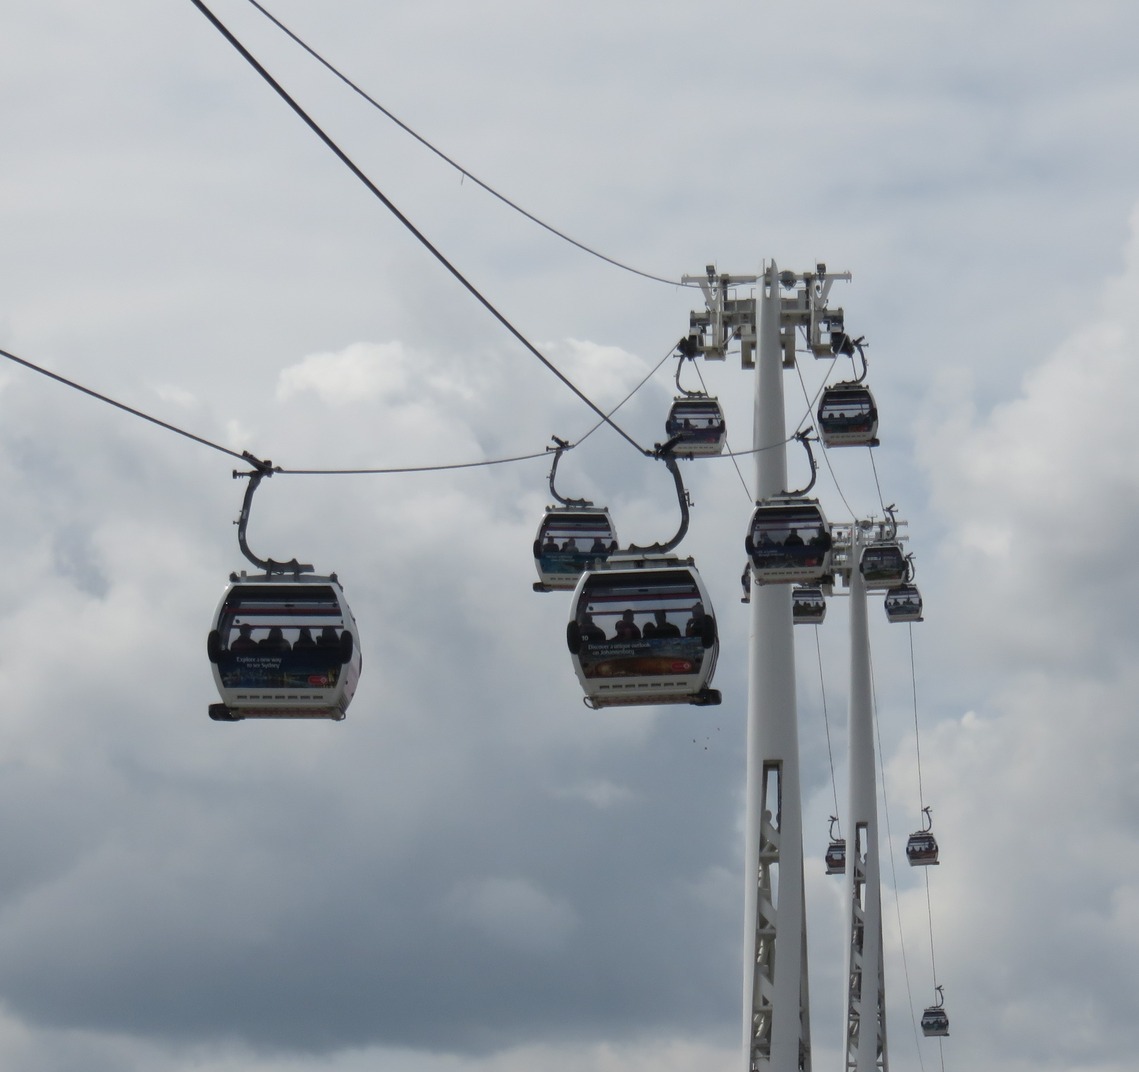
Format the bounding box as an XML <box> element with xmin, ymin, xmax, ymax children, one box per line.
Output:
<box><xmin>744</xmin><ymin>499</ymin><xmax>831</xmax><ymax>584</ymax></box>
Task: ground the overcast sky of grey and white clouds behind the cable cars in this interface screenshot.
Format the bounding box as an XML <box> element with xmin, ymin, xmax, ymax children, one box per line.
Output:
<box><xmin>0</xmin><ymin>0</ymin><xmax>1139</xmax><ymax>1072</ymax></box>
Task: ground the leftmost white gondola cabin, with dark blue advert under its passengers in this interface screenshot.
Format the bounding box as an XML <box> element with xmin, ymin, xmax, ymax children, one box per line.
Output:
<box><xmin>207</xmin><ymin>573</ymin><xmax>361</xmax><ymax>722</ymax></box>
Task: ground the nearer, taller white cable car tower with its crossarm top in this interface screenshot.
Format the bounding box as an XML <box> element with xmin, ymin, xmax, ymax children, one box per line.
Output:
<box><xmin>683</xmin><ymin>263</ymin><xmax>850</xmax><ymax>1072</ymax></box>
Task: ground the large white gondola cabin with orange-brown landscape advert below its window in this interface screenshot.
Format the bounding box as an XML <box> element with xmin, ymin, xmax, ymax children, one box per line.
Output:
<box><xmin>566</xmin><ymin>553</ymin><xmax>721</xmax><ymax>709</ymax></box>
